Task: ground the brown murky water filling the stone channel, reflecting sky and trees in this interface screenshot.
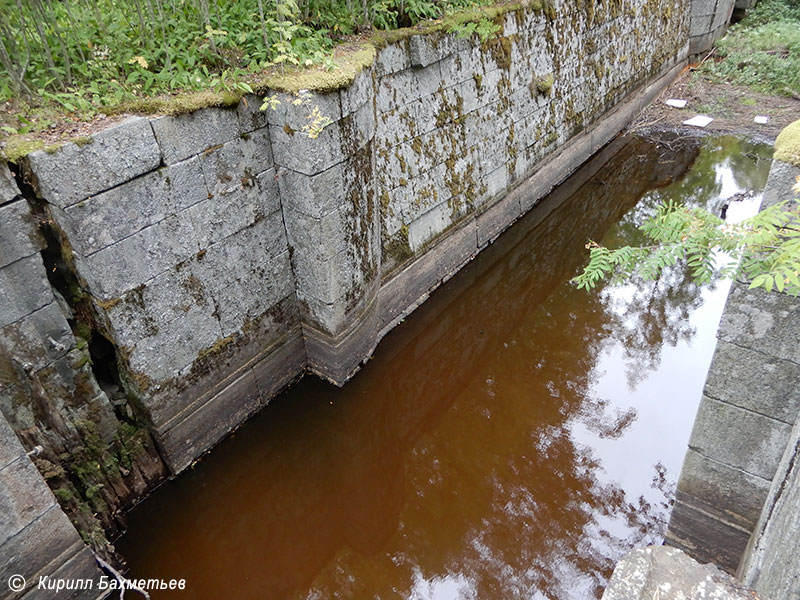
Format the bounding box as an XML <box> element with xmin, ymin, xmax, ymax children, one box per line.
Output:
<box><xmin>117</xmin><ymin>139</ymin><xmax>769</xmax><ymax>600</ymax></box>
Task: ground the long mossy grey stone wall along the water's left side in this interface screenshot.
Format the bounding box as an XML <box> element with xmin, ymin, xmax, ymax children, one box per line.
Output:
<box><xmin>3</xmin><ymin>0</ymin><xmax>689</xmax><ymax>488</ymax></box>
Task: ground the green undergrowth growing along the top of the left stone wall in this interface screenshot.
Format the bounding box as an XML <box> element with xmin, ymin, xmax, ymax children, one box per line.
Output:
<box><xmin>0</xmin><ymin>0</ymin><xmax>498</xmax><ymax>124</ymax></box>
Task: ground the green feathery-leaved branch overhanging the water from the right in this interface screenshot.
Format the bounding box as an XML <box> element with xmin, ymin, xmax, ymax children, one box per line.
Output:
<box><xmin>573</xmin><ymin>179</ymin><xmax>800</xmax><ymax>296</ymax></box>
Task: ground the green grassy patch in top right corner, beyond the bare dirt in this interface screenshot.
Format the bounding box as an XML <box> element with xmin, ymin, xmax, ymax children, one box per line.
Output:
<box><xmin>703</xmin><ymin>0</ymin><xmax>800</xmax><ymax>96</ymax></box>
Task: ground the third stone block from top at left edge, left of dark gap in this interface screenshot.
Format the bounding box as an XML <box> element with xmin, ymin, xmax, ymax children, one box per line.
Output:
<box><xmin>0</xmin><ymin>254</ymin><xmax>53</xmax><ymax>327</ymax></box>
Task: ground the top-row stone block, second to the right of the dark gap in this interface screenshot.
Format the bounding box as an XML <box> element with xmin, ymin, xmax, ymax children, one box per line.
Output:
<box><xmin>150</xmin><ymin>107</ymin><xmax>239</xmax><ymax>165</ymax></box>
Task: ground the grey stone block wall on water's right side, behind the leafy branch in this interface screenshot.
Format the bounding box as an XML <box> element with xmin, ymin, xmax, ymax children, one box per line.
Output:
<box><xmin>667</xmin><ymin>151</ymin><xmax>800</xmax><ymax>572</ymax></box>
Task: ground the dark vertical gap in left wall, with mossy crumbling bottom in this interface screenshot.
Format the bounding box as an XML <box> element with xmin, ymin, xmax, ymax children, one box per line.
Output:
<box><xmin>9</xmin><ymin>165</ymin><xmax>169</xmax><ymax>566</ymax></box>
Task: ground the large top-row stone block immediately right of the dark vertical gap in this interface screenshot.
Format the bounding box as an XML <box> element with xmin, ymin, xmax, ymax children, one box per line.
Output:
<box><xmin>27</xmin><ymin>117</ymin><xmax>161</xmax><ymax>208</ymax></box>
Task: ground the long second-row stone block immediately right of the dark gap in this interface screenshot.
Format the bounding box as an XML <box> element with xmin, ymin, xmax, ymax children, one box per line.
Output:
<box><xmin>53</xmin><ymin>157</ymin><xmax>208</xmax><ymax>257</ymax></box>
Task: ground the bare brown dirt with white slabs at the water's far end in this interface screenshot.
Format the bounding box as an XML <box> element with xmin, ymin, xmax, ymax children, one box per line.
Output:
<box><xmin>629</xmin><ymin>63</ymin><xmax>800</xmax><ymax>143</ymax></box>
